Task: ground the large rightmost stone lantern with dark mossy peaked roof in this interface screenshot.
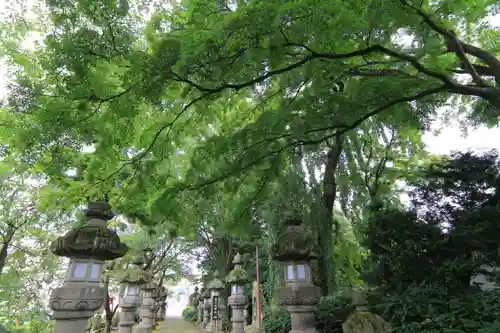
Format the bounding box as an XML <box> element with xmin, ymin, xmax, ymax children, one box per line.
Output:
<box><xmin>272</xmin><ymin>212</ymin><xmax>320</xmax><ymax>333</ymax></box>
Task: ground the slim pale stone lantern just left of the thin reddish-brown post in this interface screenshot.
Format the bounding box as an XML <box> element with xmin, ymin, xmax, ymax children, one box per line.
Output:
<box><xmin>226</xmin><ymin>253</ymin><xmax>248</xmax><ymax>333</ymax></box>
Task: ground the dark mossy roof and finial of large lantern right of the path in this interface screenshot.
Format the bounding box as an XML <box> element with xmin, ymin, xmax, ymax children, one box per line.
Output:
<box><xmin>271</xmin><ymin>211</ymin><xmax>315</xmax><ymax>261</ymax></box>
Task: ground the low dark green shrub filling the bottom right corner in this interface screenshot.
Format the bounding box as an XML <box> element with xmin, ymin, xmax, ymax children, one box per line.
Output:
<box><xmin>375</xmin><ymin>283</ymin><xmax>500</xmax><ymax>333</ymax></box>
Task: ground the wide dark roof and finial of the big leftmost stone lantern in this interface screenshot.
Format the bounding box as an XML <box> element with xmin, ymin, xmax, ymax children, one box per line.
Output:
<box><xmin>50</xmin><ymin>201</ymin><xmax>128</xmax><ymax>260</ymax></box>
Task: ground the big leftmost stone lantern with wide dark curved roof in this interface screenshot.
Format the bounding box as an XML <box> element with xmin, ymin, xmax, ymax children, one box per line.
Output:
<box><xmin>50</xmin><ymin>201</ymin><xmax>128</xmax><ymax>333</ymax></box>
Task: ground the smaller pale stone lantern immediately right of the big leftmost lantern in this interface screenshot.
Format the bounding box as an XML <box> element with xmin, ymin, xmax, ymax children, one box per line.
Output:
<box><xmin>118</xmin><ymin>257</ymin><xmax>152</xmax><ymax>333</ymax></box>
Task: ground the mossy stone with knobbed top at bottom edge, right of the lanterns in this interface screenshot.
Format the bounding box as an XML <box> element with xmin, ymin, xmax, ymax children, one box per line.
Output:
<box><xmin>342</xmin><ymin>290</ymin><xmax>392</xmax><ymax>333</ymax></box>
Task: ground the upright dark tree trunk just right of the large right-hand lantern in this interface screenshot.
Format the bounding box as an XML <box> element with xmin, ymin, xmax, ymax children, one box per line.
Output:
<box><xmin>317</xmin><ymin>135</ymin><xmax>343</xmax><ymax>296</ymax></box>
